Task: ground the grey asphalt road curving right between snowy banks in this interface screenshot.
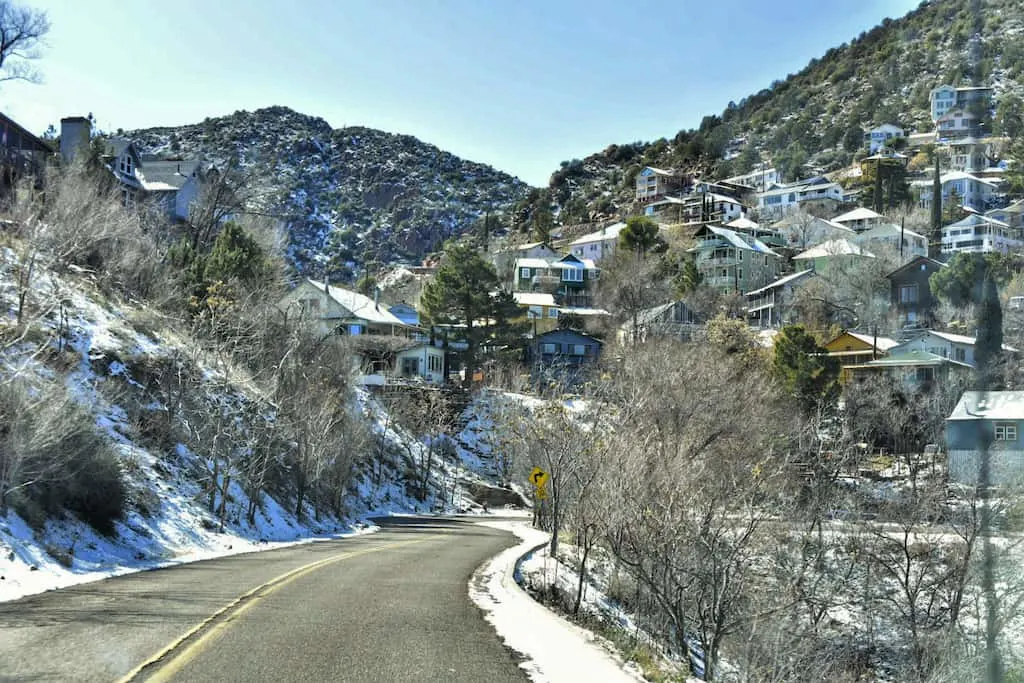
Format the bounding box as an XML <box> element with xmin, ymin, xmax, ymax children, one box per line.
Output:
<box><xmin>0</xmin><ymin>518</ymin><xmax>526</xmax><ymax>683</ymax></box>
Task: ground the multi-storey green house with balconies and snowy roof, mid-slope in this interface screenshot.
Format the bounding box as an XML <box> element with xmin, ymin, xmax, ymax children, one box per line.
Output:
<box><xmin>689</xmin><ymin>225</ymin><xmax>782</xmax><ymax>294</ymax></box>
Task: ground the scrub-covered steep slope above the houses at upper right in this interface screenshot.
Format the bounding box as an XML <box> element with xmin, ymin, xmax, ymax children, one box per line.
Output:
<box><xmin>550</xmin><ymin>0</ymin><xmax>1024</xmax><ymax>214</ymax></box>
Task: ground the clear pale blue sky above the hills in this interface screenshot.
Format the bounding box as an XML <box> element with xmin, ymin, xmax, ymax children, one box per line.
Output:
<box><xmin>0</xmin><ymin>0</ymin><xmax>919</xmax><ymax>184</ymax></box>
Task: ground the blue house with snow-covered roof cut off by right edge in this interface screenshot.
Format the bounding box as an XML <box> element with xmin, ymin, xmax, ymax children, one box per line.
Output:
<box><xmin>946</xmin><ymin>391</ymin><xmax>1024</xmax><ymax>485</ymax></box>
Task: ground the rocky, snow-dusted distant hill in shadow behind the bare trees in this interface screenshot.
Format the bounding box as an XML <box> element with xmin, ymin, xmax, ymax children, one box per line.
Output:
<box><xmin>126</xmin><ymin>106</ymin><xmax>529</xmax><ymax>276</ymax></box>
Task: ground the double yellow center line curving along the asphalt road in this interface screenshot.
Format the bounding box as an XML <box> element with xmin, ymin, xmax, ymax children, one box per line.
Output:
<box><xmin>118</xmin><ymin>533</ymin><xmax>444</xmax><ymax>683</ymax></box>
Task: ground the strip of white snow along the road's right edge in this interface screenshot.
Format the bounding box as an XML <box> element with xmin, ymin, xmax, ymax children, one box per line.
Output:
<box><xmin>469</xmin><ymin>521</ymin><xmax>644</xmax><ymax>683</ymax></box>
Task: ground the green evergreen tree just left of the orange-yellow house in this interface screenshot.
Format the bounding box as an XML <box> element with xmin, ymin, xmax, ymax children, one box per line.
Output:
<box><xmin>772</xmin><ymin>325</ymin><xmax>839</xmax><ymax>414</ymax></box>
